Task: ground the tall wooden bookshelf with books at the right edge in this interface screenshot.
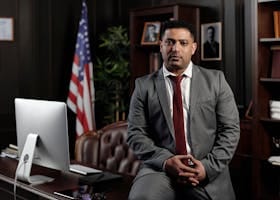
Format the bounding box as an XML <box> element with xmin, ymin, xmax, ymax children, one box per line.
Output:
<box><xmin>250</xmin><ymin>0</ymin><xmax>280</xmax><ymax>199</ymax></box>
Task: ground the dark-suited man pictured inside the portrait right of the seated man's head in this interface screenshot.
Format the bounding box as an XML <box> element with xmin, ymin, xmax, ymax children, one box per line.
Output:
<box><xmin>203</xmin><ymin>26</ymin><xmax>220</xmax><ymax>58</ymax></box>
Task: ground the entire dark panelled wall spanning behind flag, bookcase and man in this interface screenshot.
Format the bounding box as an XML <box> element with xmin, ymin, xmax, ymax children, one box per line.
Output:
<box><xmin>0</xmin><ymin>0</ymin><xmax>247</xmax><ymax>152</ymax></box>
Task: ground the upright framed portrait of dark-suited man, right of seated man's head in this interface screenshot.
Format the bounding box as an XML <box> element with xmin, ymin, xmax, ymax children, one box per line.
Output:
<box><xmin>201</xmin><ymin>22</ymin><xmax>222</xmax><ymax>61</ymax></box>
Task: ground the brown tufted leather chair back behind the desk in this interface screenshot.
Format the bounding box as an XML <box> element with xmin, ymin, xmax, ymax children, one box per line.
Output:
<box><xmin>75</xmin><ymin>121</ymin><xmax>140</xmax><ymax>176</ymax></box>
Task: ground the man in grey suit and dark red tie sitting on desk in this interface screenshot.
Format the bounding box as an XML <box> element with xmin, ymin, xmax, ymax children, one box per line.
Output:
<box><xmin>127</xmin><ymin>21</ymin><xmax>240</xmax><ymax>200</ymax></box>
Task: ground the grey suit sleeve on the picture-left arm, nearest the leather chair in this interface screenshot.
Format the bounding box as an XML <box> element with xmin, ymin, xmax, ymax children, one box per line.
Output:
<box><xmin>127</xmin><ymin>79</ymin><xmax>173</xmax><ymax>170</ymax></box>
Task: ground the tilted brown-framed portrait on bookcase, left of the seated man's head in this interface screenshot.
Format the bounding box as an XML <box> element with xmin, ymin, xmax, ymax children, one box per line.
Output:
<box><xmin>141</xmin><ymin>21</ymin><xmax>160</xmax><ymax>45</ymax></box>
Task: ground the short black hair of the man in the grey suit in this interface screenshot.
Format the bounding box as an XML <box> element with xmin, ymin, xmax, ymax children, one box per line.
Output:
<box><xmin>160</xmin><ymin>20</ymin><xmax>195</xmax><ymax>41</ymax></box>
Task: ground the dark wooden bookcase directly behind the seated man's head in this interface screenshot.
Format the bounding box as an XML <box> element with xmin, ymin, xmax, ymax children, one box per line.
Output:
<box><xmin>129</xmin><ymin>4</ymin><xmax>200</xmax><ymax>91</ymax></box>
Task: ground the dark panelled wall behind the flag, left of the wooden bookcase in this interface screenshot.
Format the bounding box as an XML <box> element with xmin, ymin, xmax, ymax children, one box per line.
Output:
<box><xmin>0</xmin><ymin>0</ymin><xmax>127</xmax><ymax>153</ymax></box>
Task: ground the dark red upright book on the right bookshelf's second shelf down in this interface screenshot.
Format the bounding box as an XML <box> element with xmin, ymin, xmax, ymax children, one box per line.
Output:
<box><xmin>270</xmin><ymin>45</ymin><xmax>280</xmax><ymax>78</ymax></box>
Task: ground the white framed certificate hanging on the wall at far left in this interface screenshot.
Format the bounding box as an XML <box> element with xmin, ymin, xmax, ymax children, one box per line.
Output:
<box><xmin>0</xmin><ymin>17</ymin><xmax>14</xmax><ymax>41</ymax></box>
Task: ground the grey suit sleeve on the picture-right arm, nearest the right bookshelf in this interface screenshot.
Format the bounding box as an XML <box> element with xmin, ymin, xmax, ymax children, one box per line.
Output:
<box><xmin>201</xmin><ymin>73</ymin><xmax>240</xmax><ymax>181</ymax></box>
